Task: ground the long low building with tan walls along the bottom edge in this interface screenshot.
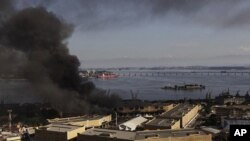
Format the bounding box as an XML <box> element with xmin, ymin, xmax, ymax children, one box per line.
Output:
<box><xmin>78</xmin><ymin>129</ymin><xmax>212</xmax><ymax>141</ymax></box>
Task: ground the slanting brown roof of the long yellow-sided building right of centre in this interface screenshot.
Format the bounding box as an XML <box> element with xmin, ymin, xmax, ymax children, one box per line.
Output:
<box><xmin>161</xmin><ymin>103</ymin><xmax>196</xmax><ymax>118</ymax></box>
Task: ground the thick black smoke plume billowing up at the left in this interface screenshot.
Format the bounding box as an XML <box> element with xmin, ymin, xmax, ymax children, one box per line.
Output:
<box><xmin>0</xmin><ymin>7</ymin><xmax>92</xmax><ymax>113</ymax></box>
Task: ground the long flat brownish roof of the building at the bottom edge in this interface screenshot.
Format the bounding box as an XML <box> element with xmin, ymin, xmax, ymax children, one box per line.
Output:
<box><xmin>82</xmin><ymin>129</ymin><xmax>207</xmax><ymax>140</ymax></box>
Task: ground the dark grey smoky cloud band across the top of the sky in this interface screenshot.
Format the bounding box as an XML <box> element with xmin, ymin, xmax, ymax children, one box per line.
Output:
<box><xmin>16</xmin><ymin>0</ymin><xmax>250</xmax><ymax>31</ymax></box>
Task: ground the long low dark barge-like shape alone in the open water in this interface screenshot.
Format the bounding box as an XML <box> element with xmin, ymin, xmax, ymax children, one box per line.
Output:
<box><xmin>162</xmin><ymin>84</ymin><xmax>206</xmax><ymax>90</ymax></box>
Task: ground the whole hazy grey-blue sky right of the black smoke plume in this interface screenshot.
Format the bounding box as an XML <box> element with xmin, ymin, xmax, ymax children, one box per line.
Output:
<box><xmin>16</xmin><ymin>0</ymin><xmax>250</xmax><ymax>68</ymax></box>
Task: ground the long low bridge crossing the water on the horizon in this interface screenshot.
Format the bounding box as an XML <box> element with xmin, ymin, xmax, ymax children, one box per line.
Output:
<box><xmin>115</xmin><ymin>71</ymin><xmax>250</xmax><ymax>77</ymax></box>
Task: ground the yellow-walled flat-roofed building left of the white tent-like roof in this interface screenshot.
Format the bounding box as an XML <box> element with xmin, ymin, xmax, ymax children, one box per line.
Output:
<box><xmin>48</xmin><ymin>115</ymin><xmax>112</xmax><ymax>128</ymax></box>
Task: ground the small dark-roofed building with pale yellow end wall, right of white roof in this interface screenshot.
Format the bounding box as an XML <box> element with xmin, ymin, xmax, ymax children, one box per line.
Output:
<box><xmin>144</xmin><ymin>117</ymin><xmax>181</xmax><ymax>130</ymax></box>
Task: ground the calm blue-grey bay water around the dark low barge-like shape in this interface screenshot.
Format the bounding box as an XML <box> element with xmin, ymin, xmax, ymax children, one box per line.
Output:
<box><xmin>91</xmin><ymin>70</ymin><xmax>250</xmax><ymax>100</ymax></box>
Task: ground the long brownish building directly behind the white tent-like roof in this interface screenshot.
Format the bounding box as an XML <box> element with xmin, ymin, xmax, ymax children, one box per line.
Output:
<box><xmin>115</xmin><ymin>100</ymin><xmax>174</xmax><ymax>115</ymax></box>
